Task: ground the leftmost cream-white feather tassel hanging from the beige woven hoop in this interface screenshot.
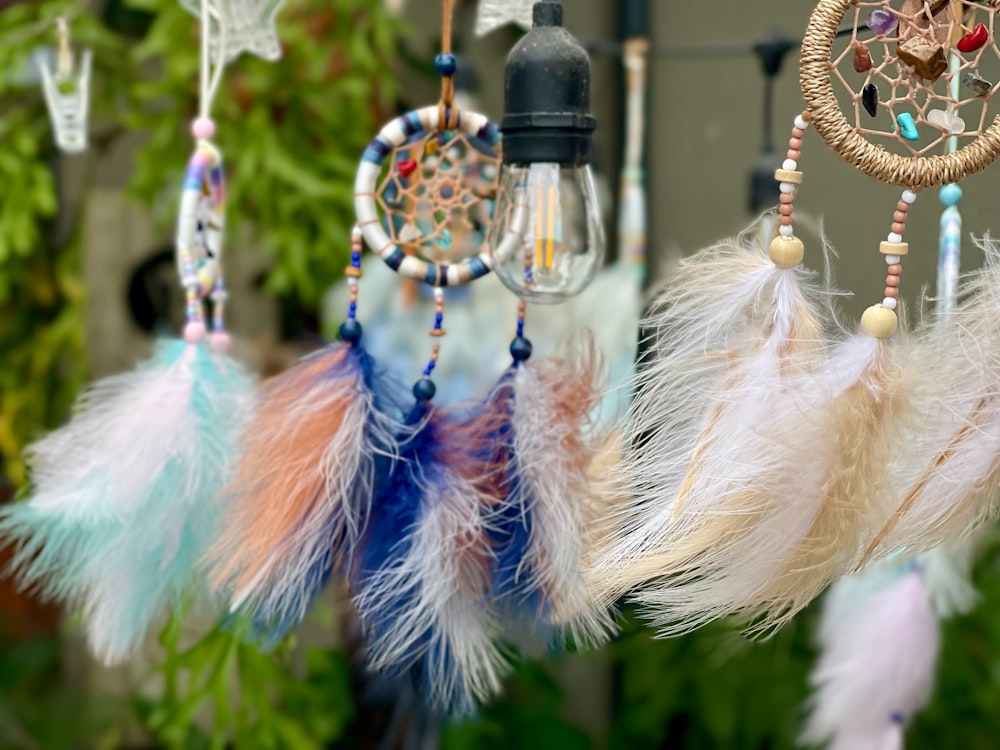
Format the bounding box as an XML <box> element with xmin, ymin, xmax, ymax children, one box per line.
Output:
<box><xmin>593</xmin><ymin>237</ymin><xmax>828</xmax><ymax>633</ymax></box>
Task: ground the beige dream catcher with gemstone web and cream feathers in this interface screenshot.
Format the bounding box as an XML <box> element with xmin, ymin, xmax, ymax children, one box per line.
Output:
<box><xmin>595</xmin><ymin>0</ymin><xmax>1000</xmax><ymax>633</ymax></box>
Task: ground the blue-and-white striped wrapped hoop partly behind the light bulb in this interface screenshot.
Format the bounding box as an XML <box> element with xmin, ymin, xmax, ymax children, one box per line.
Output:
<box><xmin>354</xmin><ymin>105</ymin><xmax>527</xmax><ymax>287</ymax></box>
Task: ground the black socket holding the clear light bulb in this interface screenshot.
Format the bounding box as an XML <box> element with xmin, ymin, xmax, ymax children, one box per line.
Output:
<box><xmin>500</xmin><ymin>0</ymin><xmax>597</xmax><ymax>166</ymax></box>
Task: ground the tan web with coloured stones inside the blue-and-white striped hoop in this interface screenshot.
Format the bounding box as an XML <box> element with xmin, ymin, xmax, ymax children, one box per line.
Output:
<box><xmin>373</xmin><ymin>130</ymin><xmax>500</xmax><ymax>263</ymax></box>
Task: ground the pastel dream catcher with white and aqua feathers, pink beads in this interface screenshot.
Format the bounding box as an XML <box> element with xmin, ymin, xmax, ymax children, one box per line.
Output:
<box><xmin>0</xmin><ymin>2</ymin><xmax>252</xmax><ymax>663</ymax></box>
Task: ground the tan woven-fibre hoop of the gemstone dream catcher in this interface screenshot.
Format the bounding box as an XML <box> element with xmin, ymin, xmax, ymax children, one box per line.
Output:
<box><xmin>799</xmin><ymin>0</ymin><xmax>1000</xmax><ymax>188</ymax></box>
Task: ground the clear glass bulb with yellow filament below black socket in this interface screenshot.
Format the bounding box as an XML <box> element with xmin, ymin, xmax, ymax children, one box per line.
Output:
<box><xmin>486</xmin><ymin>163</ymin><xmax>605</xmax><ymax>304</ymax></box>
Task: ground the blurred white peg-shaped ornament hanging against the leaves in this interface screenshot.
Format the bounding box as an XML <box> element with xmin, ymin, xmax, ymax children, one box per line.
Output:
<box><xmin>35</xmin><ymin>17</ymin><xmax>93</xmax><ymax>154</ymax></box>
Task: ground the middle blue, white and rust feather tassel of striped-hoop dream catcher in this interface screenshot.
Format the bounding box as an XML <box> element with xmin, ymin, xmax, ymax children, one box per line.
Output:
<box><xmin>351</xmin><ymin>403</ymin><xmax>509</xmax><ymax>714</ymax></box>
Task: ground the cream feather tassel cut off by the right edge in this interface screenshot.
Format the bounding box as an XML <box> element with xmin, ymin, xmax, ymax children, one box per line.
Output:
<box><xmin>861</xmin><ymin>240</ymin><xmax>1000</xmax><ymax>564</ymax></box>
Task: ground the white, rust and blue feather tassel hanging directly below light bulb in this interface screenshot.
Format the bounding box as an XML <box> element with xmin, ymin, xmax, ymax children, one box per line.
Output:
<box><xmin>485</xmin><ymin>338</ymin><xmax>613</xmax><ymax>645</ymax></box>
